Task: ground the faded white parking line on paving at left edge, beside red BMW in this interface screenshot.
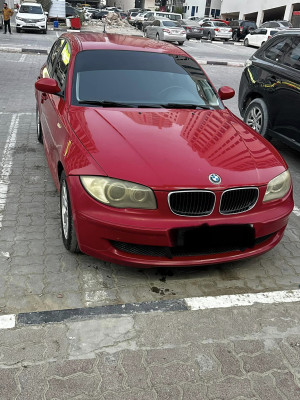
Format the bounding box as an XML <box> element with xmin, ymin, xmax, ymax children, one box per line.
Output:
<box><xmin>0</xmin><ymin>114</ymin><xmax>19</xmax><ymax>230</ymax></box>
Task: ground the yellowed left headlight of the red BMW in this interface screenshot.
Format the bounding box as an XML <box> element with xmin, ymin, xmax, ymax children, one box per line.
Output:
<box><xmin>80</xmin><ymin>176</ymin><xmax>157</xmax><ymax>210</ymax></box>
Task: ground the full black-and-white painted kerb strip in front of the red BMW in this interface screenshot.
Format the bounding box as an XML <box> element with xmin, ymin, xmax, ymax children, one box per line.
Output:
<box><xmin>0</xmin><ymin>289</ymin><xmax>300</xmax><ymax>331</ymax></box>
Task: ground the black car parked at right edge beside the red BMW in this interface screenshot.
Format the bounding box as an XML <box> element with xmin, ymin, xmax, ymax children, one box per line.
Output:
<box><xmin>239</xmin><ymin>29</ymin><xmax>300</xmax><ymax>150</ymax></box>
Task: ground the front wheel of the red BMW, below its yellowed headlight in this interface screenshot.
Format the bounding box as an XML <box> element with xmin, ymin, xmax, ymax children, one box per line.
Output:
<box><xmin>60</xmin><ymin>172</ymin><xmax>80</xmax><ymax>253</ymax></box>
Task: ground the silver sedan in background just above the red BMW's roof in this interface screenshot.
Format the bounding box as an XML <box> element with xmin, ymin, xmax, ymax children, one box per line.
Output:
<box><xmin>144</xmin><ymin>19</ymin><xmax>186</xmax><ymax>46</ymax></box>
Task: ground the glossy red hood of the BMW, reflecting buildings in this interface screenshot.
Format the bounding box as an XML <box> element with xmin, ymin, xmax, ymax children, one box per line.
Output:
<box><xmin>69</xmin><ymin>107</ymin><xmax>287</xmax><ymax>190</ymax></box>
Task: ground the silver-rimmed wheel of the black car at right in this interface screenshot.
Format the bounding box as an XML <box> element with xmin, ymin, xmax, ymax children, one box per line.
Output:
<box><xmin>244</xmin><ymin>98</ymin><xmax>271</xmax><ymax>140</ymax></box>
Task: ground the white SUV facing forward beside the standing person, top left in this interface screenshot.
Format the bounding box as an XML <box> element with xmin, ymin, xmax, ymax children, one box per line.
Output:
<box><xmin>16</xmin><ymin>3</ymin><xmax>48</xmax><ymax>33</ymax></box>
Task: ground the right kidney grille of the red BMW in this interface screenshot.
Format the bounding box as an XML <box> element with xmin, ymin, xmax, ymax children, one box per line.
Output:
<box><xmin>220</xmin><ymin>188</ymin><xmax>258</xmax><ymax>214</ymax></box>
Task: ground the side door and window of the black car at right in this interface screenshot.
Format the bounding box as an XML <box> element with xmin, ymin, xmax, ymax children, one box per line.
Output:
<box><xmin>264</xmin><ymin>35</ymin><xmax>300</xmax><ymax>144</ymax></box>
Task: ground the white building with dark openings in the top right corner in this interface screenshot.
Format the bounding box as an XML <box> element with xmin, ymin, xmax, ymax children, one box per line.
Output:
<box><xmin>221</xmin><ymin>0</ymin><xmax>300</xmax><ymax>27</ymax></box>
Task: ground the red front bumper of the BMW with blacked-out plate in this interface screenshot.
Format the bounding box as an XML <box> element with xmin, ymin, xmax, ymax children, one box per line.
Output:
<box><xmin>68</xmin><ymin>176</ymin><xmax>294</xmax><ymax>267</ymax></box>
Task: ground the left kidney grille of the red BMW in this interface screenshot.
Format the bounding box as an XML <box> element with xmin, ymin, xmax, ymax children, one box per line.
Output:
<box><xmin>169</xmin><ymin>190</ymin><xmax>215</xmax><ymax>216</ymax></box>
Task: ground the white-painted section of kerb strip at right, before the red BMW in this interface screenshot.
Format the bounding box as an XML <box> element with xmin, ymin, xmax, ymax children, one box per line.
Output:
<box><xmin>185</xmin><ymin>290</ymin><xmax>300</xmax><ymax>311</ymax></box>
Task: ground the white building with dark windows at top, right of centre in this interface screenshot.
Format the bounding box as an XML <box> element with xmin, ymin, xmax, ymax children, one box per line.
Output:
<box><xmin>183</xmin><ymin>0</ymin><xmax>222</xmax><ymax>18</ymax></box>
